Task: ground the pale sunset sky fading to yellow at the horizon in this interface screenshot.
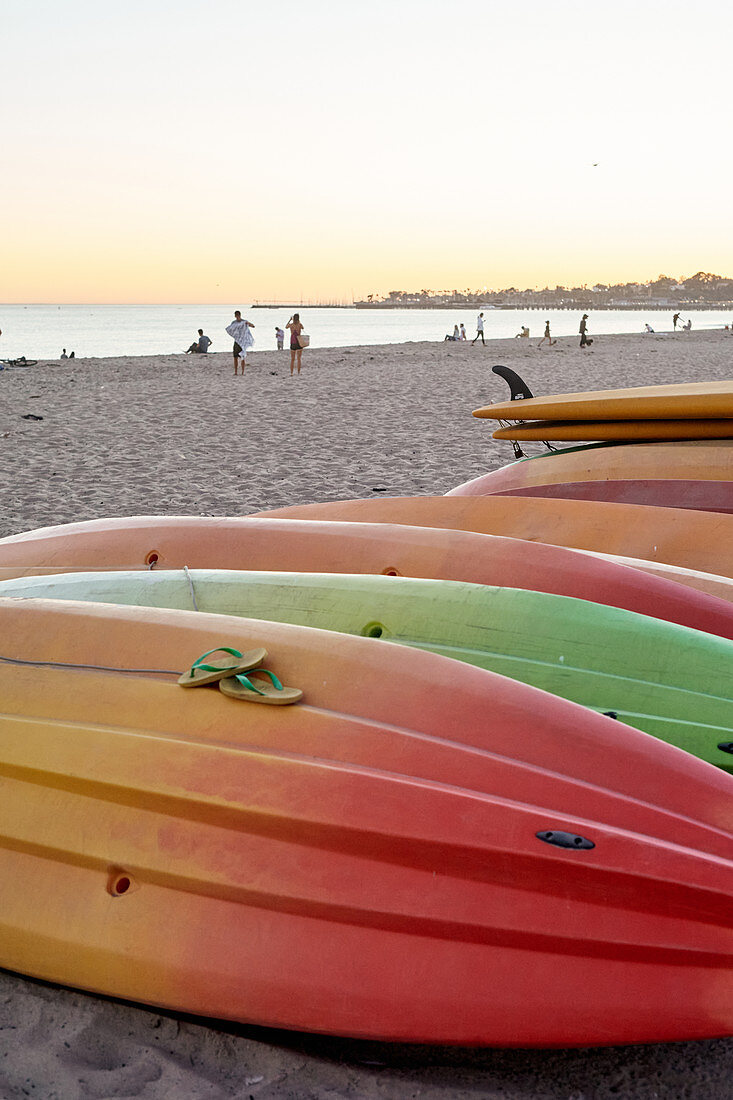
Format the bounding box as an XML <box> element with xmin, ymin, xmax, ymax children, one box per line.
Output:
<box><xmin>0</xmin><ymin>0</ymin><xmax>733</xmax><ymax>304</ymax></box>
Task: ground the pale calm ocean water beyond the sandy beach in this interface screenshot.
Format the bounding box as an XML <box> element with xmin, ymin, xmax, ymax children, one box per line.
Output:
<box><xmin>0</xmin><ymin>303</ymin><xmax>733</xmax><ymax>359</ymax></box>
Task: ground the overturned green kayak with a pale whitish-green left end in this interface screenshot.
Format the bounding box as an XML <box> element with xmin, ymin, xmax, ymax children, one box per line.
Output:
<box><xmin>5</xmin><ymin>569</ymin><xmax>733</xmax><ymax>771</ymax></box>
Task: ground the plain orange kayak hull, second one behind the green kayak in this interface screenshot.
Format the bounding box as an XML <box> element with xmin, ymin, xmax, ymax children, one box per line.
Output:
<box><xmin>254</xmin><ymin>496</ymin><xmax>733</xmax><ymax>576</ymax></box>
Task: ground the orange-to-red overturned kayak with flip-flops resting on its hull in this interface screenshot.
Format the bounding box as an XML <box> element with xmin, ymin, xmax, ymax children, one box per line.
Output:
<box><xmin>0</xmin><ymin>600</ymin><xmax>733</xmax><ymax>1046</ymax></box>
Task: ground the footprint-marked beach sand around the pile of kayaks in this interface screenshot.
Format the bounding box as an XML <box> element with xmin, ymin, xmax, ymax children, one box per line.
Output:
<box><xmin>0</xmin><ymin>332</ymin><xmax>733</xmax><ymax>1100</ymax></box>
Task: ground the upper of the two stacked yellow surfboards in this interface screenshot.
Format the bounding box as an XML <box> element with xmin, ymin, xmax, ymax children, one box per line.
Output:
<box><xmin>473</xmin><ymin>382</ymin><xmax>733</xmax><ymax>421</ymax></box>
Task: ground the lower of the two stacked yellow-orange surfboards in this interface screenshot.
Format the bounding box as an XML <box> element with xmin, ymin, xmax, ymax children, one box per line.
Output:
<box><xmin>488</xmin><ymin>418</ymin><xmax>733</xmax><ymax>442</ymax></box>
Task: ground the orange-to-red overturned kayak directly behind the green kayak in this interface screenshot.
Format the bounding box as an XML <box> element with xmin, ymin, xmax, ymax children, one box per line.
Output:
<box><xmin>0</xmin><ymin>512</ymin><xmax>733</xmax><ymax>638</ymax></box>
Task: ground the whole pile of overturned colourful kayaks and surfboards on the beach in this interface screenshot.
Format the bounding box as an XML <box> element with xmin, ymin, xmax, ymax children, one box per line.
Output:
<box><xmin>0</xmin><ymin>372</ymin><xmax>733</xmax><ymax>1046</ymax></box>
